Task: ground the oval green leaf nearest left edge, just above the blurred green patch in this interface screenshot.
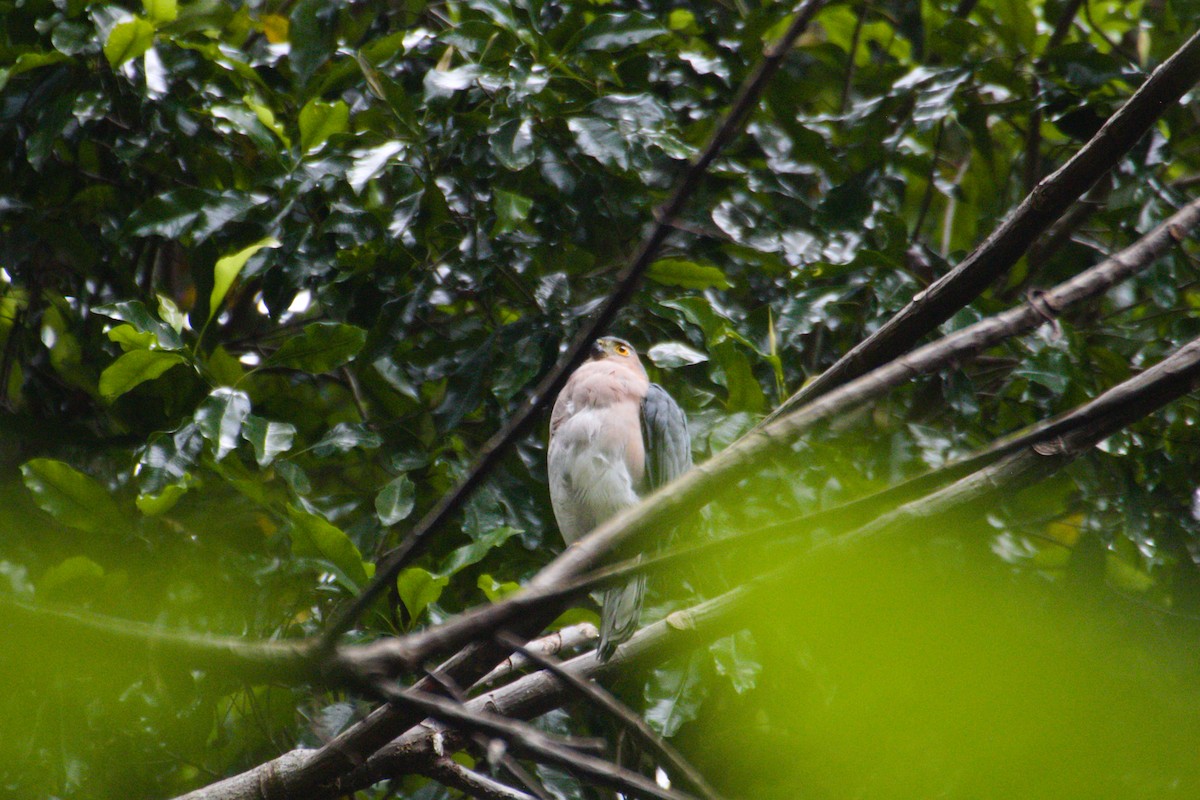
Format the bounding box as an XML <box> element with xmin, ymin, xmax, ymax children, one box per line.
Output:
<box><xmin>20</xmin><ymin>458</ymin><xmax>126</xmax><ymax>534</ymax></box>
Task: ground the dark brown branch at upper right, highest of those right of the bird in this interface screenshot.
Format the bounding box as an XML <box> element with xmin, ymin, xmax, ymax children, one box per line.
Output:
<box><xmin>766</xmin><ymin>26</ymin><xmax>1200</xmax><ymax>422</ymax></box>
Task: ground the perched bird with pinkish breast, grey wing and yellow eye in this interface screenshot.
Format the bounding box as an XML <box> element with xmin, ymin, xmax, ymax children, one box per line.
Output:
<box><xmin>546</xmin><ymin>337</ymin><xmax>691</xmax><ymax>661</ymax></box>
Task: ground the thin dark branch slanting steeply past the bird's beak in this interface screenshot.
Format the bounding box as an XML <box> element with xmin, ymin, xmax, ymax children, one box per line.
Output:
<box><xmin>323</xmin><ymin>0</ymin><xmax>823</xmax><ymax>649</ymax></box>
